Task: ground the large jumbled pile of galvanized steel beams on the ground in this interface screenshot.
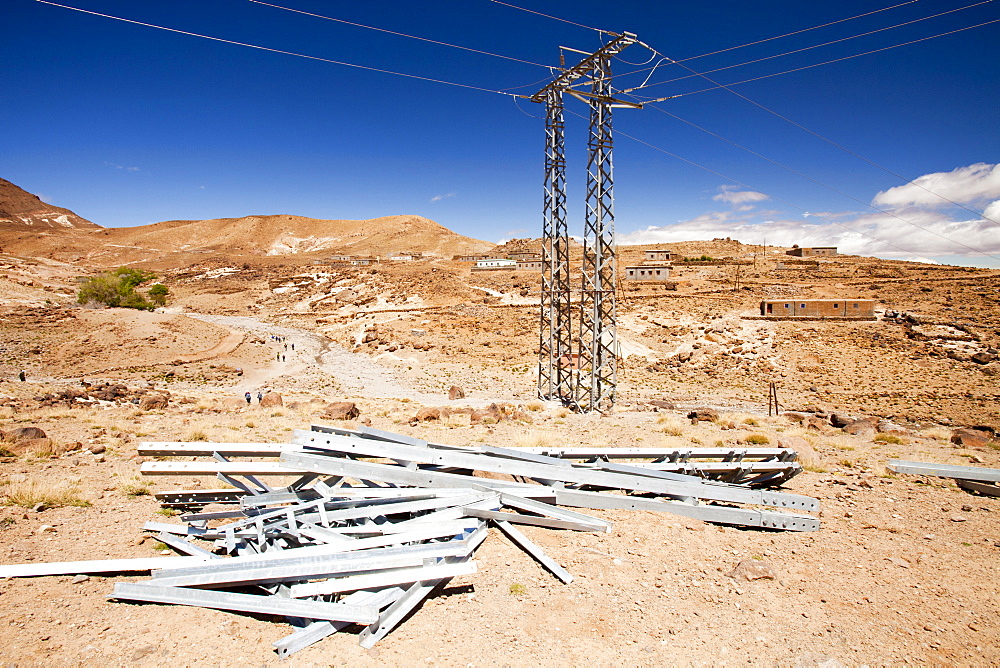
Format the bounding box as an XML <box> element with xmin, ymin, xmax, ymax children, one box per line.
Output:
<box><xmin>0</xmin><ymin>426</ymin><xmax>819</xmax><ymax>656</ymax></box>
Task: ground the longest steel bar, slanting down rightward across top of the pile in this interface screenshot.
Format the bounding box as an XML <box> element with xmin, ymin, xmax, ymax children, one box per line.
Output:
<box><xmin>292</xmin><ymin>431</ymin><xmax>818</xmax><ymax>510</ymax></box>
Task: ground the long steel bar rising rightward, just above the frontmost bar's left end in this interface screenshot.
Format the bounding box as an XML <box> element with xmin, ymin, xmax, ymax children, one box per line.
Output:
<box><xmin>148</xmin><ymin>539</ymin><xmax>472</xmax><ymax>587</ymax></box>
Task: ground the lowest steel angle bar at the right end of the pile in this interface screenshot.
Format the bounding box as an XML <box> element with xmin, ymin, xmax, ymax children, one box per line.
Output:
<box><xmin>557</xmin><ymin>490</ymin><xmax>820</xmax><ymax>531</ymax></box>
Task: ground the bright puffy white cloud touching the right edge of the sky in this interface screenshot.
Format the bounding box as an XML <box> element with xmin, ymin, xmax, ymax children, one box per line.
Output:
<box><xmin>872</xmin><ymin>162</ymin><xmax>1000</xmax><ymax>208</ymax></box>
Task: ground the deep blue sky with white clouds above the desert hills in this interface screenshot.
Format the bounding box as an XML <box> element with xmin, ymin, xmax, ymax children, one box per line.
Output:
<box><xmin>0</xmin><ymin>0</ymin><xmax>1000</xmax><ymax>267</ymax></box>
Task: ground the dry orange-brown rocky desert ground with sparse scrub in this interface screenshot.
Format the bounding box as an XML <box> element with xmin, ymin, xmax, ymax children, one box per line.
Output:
<box><xmin>0</xmin><ymin>239</ymin><xmax>1000</xmax><ymax>666</ymax></box>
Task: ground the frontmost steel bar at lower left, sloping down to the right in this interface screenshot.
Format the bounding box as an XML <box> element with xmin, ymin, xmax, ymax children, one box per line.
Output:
<box><xmin>108</xmin><ymin>582</ymin><xmax>378</xmax><ymax>624</ymax></box>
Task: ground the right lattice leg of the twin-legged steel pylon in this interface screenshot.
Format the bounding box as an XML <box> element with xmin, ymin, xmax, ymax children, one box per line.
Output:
<box><xmin>577</xmin><ymin>55</ymin><xmax>618</xmax><ymax>412</ymax></box>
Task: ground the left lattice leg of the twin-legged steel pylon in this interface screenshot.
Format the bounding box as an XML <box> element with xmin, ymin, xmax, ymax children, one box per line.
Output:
<box><xmin>538</xmin><ymin>89</ymin><xmax>574</xmax><ymax>399</ymax></box>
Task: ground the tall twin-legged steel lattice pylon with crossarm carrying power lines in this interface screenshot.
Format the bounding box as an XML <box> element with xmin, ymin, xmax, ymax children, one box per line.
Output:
<box><xmin>530</xmin><ymin>33</ymin><xmax>642</xmax><ymax>411</ymax></box>
